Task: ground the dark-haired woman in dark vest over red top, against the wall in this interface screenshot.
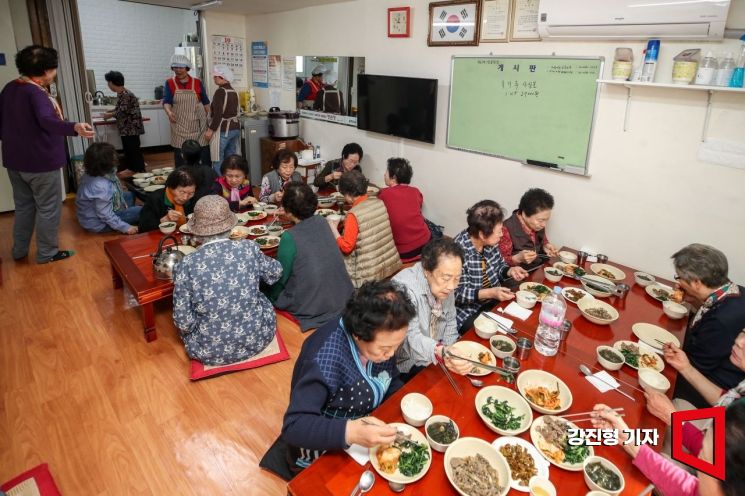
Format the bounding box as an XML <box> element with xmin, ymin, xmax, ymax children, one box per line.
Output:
<box><xmin>499</xmin><ymin>188</ymin><xmax>558</xmax><ymax>269</ymax></box>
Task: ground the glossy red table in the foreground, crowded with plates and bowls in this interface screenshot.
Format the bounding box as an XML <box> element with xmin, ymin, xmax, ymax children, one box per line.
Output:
<box><xmin>288</xmin><ymin>250</ymin><xmax>685</xmax><ymax>496</ymax></box>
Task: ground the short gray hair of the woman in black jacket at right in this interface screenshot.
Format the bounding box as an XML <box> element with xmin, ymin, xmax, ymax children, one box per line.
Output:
<box><xmin>672</xmin><ymin>243</ymin><xmax>729</xmax><ymax>288</ymax></box>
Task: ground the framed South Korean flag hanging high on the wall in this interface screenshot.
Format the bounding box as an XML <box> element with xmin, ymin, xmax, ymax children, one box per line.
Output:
<box><xmin>427</xmin><ymin>0</ymin><xmax>482</xmax><ymax>46</ymax></box>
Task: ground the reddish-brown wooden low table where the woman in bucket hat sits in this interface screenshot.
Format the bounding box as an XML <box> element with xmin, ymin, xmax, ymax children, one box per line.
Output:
<box><xmin>104</xmin><ymin>211</ymin><xmax>288</xmax><ymax>342</ymax></box>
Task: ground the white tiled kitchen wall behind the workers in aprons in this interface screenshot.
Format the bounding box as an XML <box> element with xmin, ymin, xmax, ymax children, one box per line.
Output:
<box><xmin>78</xmin><ymin>0</ymin><xmax>197</xmax><ymax>99</ymax></box>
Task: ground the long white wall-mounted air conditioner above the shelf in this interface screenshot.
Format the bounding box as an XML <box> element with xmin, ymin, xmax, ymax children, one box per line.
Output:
<box><xmin>538</xmin><ymin>0</ymin><xmax>730</xmax><ymax>40</ymax></box>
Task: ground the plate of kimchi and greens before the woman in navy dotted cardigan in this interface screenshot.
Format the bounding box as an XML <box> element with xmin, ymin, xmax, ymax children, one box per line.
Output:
<box><xmin>370</xmin><ymin>422</ymin><xmax>432</xmax><ymax>484</ymax></box>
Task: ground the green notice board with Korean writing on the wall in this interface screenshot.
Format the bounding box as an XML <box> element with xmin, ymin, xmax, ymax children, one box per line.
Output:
<box><xmin>447</xmin><ymin>55</ymin><xmax>604</xmax><ymax>175</ymax></box>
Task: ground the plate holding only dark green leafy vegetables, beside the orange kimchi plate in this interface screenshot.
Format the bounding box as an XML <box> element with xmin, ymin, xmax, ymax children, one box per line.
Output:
<box><xmin>476</xmin><ymin>386</ymin><xmax>533</xmax><ymax>436</ymax></box>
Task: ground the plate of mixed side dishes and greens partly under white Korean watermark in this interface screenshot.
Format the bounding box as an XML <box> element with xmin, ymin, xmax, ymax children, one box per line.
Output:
<box><xmin>530</xmin><ymin>415</ymin><xmax>595</xmax><ymax>472</ymax></box>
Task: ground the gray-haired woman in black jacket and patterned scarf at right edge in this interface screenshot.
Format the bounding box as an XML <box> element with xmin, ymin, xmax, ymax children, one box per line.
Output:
<box><xmin>672</xmin><ymin>243</ymin><xmax>745</xmax><ymax>408</ymax></box>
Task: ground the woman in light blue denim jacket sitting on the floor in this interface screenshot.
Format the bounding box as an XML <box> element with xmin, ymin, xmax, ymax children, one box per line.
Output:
<box><xmin>75</xmin><ymin>143</ymin><xmax>142</xmax><ymax>234</ymax></box>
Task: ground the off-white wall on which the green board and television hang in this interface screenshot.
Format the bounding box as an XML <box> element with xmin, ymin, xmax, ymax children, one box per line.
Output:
<box><xmin>246</xmin><ymin>0</ymin><xmax>745</xmax><ymax>283</ymax></box>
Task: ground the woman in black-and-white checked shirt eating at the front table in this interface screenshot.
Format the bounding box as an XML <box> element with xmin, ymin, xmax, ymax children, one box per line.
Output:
<box><xmin>455</xmin><ymin>200</ymin><xmax>528</xmax><ymax>334</ymax></box>
